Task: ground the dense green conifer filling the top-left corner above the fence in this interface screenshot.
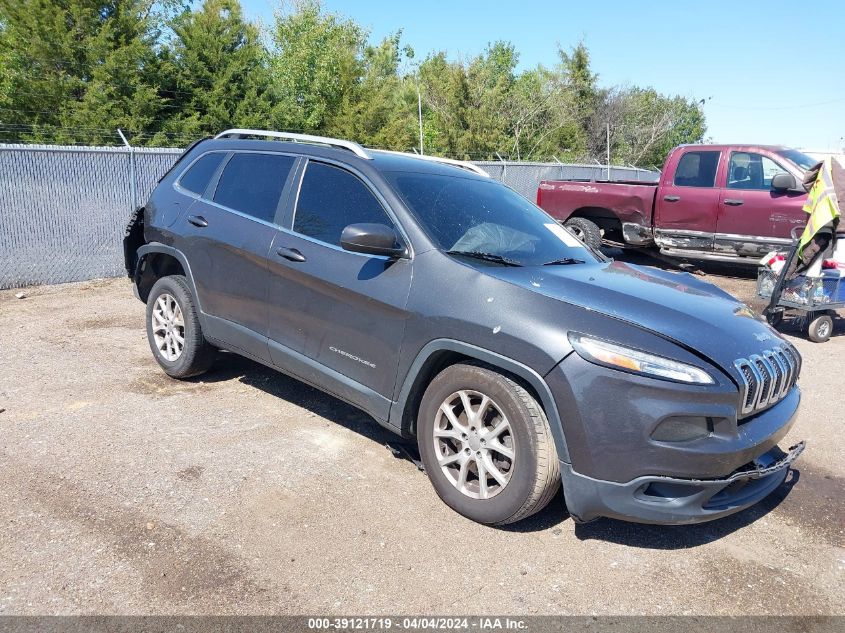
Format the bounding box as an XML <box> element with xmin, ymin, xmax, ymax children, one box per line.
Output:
<box><xmin>0</xmin><ymin>0</ymin><xmax>172</xmax><ymax>143</ymax></box>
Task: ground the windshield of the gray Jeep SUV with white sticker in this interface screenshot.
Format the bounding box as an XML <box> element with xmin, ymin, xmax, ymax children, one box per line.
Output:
<box><xmin>384</xmin><ymin>172</ymin><xmax>598</xmax><ymax>266</ymax></box>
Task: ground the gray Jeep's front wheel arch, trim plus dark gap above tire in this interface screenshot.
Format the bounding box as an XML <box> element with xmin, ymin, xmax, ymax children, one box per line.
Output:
<box><xmin>390</xmin><ymin>339</ymin><xmax>570</xmax><ymax>463</ymax></box>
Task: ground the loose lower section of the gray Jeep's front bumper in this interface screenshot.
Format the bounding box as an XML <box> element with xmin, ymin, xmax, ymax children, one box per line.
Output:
<box><xmin>560</xmin><ymin>442</ymin><xmax>804</xmax><ymax>525</ymax></box>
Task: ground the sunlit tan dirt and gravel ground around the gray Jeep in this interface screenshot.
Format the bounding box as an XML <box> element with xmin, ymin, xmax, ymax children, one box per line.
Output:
<box><xmin>0</xmin><ymin>254</ymin><xmax>845</xmax><ymax>614</ymax></box>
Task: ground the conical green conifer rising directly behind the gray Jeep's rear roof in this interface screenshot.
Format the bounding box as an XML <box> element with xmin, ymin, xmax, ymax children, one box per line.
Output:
<box><xmin>154</xmin><ymin>0</ymin><xmax>272</xmax><ymax>143</ymax></box>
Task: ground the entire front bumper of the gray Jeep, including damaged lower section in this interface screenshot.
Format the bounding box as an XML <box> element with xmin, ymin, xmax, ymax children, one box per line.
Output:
<box><xmin>546</xmin><ymin>354</ymin><xmax>803</xmax><ymax>524</ymax></box>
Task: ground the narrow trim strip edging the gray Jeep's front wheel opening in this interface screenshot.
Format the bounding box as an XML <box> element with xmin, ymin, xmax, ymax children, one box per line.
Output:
<box><xmin>390</xmin><ymin>339</ymin><xmax>571</xmax><ymax>463</ymax></box>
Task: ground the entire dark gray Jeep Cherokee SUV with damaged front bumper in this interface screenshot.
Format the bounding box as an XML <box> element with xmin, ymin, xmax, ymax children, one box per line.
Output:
<box><xmin>124</xmin><ymin>130</ymin><xmax>803</xmax><ymax>524</ymax></box>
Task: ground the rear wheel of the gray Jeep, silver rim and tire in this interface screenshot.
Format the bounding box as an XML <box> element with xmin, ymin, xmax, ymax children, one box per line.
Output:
<box><xmin>147</xmin><ymin>275</ymin><xmax>214</xmax><ymax>378</ymax></box>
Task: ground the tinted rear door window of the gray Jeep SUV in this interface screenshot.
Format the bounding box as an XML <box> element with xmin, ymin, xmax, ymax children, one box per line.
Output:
<box><xmin>214</xmin><ymin>154</ymin><xmax>294</xmax><ymax>222</ymax></box>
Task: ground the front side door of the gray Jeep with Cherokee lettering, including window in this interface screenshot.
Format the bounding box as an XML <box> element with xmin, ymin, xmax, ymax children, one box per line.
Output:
<box><xmin>268</xmin><ymin>160</ymin><xmax>413</xmax><ymax>419</ymax></box>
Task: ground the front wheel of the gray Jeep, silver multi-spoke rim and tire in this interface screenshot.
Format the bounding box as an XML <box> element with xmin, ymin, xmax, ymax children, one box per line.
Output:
<box><xmin>417</xmin><ymin>364</ymin><xmax>560</xmax><ymax>525</ymax></box>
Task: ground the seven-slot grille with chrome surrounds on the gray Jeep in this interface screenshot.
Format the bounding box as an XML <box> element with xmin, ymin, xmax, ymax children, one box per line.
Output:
<box><xmin>734</xmin><ymin>347</ymin><xmax>801</xmax><ymax>415</ymax></box>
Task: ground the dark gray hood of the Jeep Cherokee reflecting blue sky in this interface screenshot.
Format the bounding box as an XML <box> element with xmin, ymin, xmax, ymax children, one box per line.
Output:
<box><xmin>487</xmin><ymin>262</ymin><xmax>783</xmax><ymax>376</ymax></box>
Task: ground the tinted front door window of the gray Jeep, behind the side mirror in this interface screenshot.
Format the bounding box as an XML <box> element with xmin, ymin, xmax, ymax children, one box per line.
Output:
<box><xmin>293</xmin><ymin>162</ymin><xmax>393</xmax><ymax>245</ymax></box>
